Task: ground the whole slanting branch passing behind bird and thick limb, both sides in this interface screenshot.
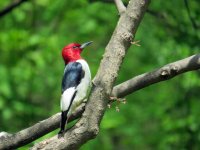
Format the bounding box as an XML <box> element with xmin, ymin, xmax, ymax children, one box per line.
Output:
<box><xmin>0</xmin><ymin>54</ymin><xmax>200</xmax><ymax>149</ymax></box>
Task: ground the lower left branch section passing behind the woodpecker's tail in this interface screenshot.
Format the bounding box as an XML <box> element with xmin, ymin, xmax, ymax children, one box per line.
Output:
<box><xmin>0</xmin><ymin>103</ymin><xmax>85</xmax><ymax>149</ymax></box>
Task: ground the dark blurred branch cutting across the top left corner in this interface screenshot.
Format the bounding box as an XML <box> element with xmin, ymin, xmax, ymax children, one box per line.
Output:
<box><xmin>0</xmin><ymin>0</ymin><xmax>28</xmax><ymax>17</ymax></box>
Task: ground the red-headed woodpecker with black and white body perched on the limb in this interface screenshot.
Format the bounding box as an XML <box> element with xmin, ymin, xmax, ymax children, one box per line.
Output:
<box><xmin>58</xmin><ymin>41</ymin><xmax>92</xmax><ymax>137</ymax></box>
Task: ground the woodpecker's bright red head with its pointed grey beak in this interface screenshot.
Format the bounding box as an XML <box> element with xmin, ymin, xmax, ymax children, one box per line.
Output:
<box><xmin>62</xmin><ymin>42</ymin><xmax>92</xmax><ymax>64</ymax></box>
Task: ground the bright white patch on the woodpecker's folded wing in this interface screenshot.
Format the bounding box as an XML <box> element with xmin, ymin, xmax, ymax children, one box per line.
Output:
<box><xmin>60</xmin><ymin>87</ymin><xmax>76</xmax><ymax>111</ymax></box>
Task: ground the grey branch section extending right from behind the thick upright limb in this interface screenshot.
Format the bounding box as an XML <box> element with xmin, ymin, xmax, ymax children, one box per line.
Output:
<box><xmin>112</xmin><ymin>54</ymin><xmax>200</xmax><ymax>97</ymax></box>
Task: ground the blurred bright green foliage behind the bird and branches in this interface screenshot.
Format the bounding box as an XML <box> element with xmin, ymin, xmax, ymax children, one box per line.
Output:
<box><xmin>0</xmin><ymin>0</ymin><xmax>200</xmax><ymax>150</ymax></box>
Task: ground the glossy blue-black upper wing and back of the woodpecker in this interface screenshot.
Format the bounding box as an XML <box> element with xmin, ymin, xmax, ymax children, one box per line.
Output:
<box><xmin>62</xmin><ymin>62</ymin><xmax>85</xmax><ymax>93</ymax></box>
